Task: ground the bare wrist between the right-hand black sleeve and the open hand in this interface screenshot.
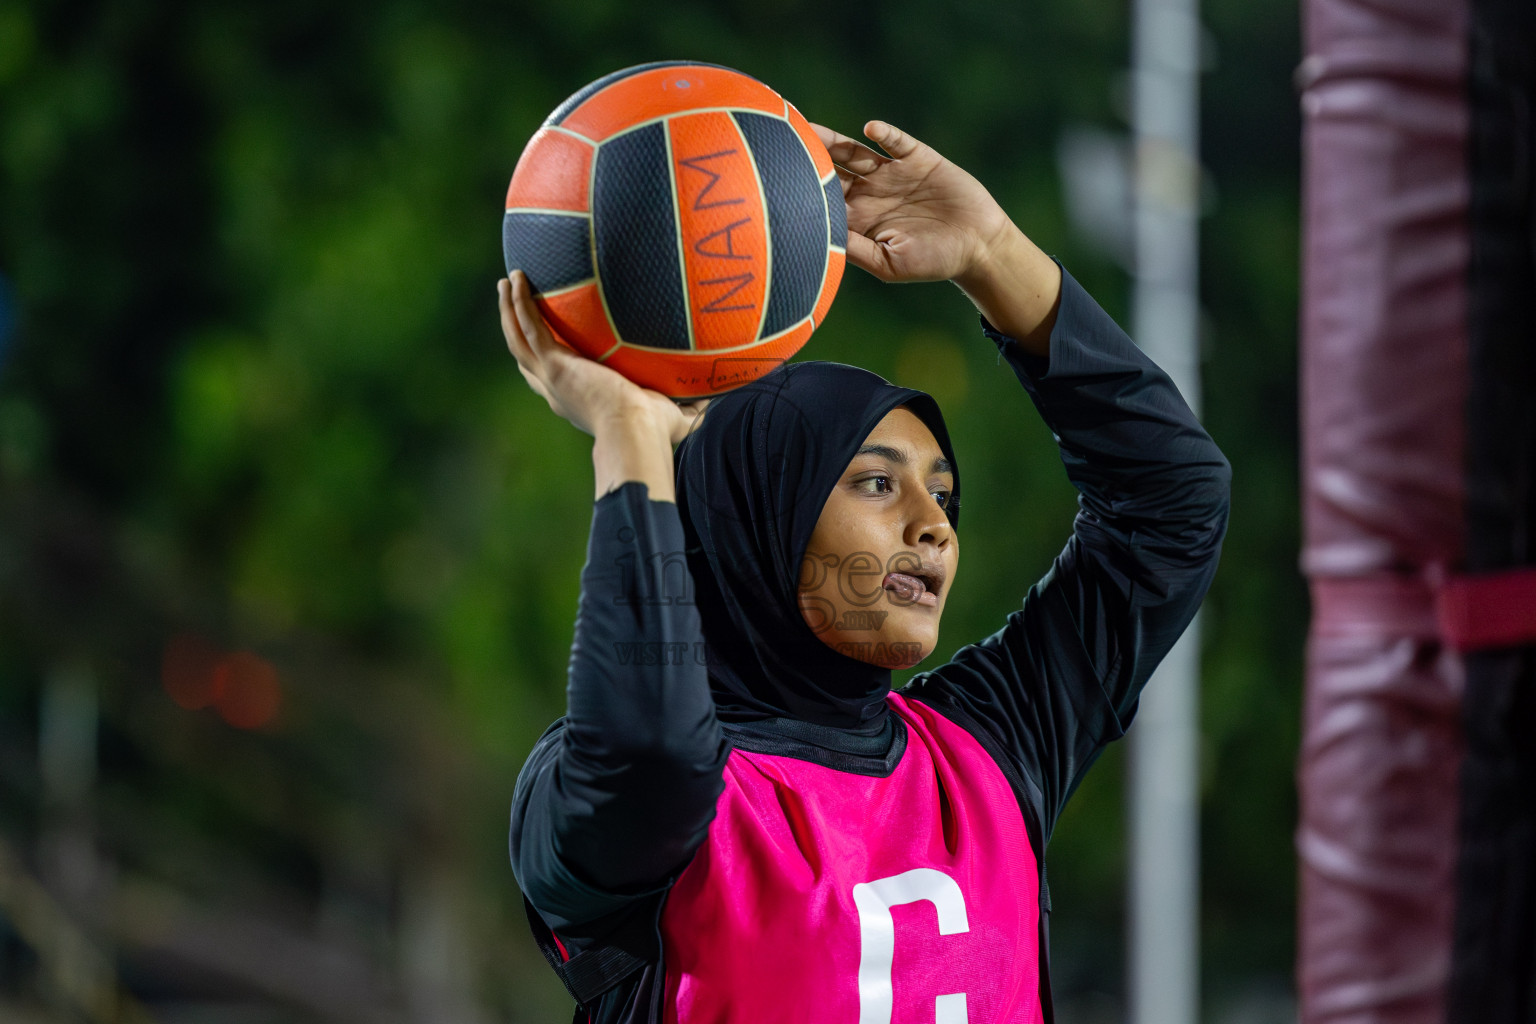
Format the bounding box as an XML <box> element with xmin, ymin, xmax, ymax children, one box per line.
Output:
<box><xmin>955</xmin><ymin>223</ymin><xmax>1061</xmax><ymax>358</ymax></box>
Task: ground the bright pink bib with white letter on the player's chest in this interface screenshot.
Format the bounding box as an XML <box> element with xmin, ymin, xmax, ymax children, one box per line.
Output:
<box><xmin>660</xmin><ymin>694</ymin><xmax>1041</xmax><ymax>1024</ymax></box>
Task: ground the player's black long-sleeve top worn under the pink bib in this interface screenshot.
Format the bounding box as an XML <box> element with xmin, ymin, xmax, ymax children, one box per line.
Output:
<box><xmin>510</xmin><ymin>272</ymin><xmax>1230</xmax><ymax>1021</ymax></box>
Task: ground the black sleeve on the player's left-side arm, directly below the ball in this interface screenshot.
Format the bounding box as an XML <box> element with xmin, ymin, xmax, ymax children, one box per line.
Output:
<box><xmin>511</xmin><ymin>487</ymin><xmax>730</xmax><ymax>927</ymax></box>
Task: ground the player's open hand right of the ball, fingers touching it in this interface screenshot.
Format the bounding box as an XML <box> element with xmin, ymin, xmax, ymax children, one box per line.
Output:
<box><xmin>811</xmin><ymin>121</ymin><xmax>1020</xmax><ymax>281</ymax></box>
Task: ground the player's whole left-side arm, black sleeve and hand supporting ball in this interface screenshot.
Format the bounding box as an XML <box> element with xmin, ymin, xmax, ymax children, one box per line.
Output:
<box><xmin>498</xmin><ymin>272</ymin><xmax>725</xmax><ymax>927</ymax></box>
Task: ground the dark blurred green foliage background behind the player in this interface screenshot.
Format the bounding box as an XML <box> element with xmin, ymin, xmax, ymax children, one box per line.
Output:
<box><xmin>0</xmin><ymin>0</ymin><xmax>1306</xmax><ymax>1021</ymax></box>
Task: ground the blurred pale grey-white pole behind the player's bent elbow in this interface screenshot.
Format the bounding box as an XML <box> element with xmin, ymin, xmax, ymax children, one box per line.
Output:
<box><xmin>1127</xmin><ymin>0</ymin><xmax>1200</xmax><ymax>1024</ymax></box>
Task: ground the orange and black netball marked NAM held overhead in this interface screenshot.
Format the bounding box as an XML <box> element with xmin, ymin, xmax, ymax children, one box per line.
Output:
<box><xmin>502</xmin><ymin>61</ymin><xmax>848</xmax><ymax>398</ymax></box>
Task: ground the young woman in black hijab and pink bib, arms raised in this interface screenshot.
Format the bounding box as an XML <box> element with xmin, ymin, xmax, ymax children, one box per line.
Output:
<box><xmin>499</xmin><ymin>121</ymin><xmax>1229</xmax><ymax>1024</ymax></box>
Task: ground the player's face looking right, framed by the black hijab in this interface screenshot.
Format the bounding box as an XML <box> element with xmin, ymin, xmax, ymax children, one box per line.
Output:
<box><xmin>799</xmin><ymin>407</ymin><xmax>960</xmax><ymax>668</ymax></box>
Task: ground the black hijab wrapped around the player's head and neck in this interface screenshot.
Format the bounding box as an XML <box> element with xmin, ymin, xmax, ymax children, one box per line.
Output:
<box><xmin>674</xmin><ymin>361</ymin><xmax>960</xmax><ymax>731</ymax></box>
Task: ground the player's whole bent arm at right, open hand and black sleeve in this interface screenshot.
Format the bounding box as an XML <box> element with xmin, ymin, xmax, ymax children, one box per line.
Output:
<box><xmin>817</xmin><ymin>121</ymin><xmax>1230</xmax><ymax>832</ymax></box>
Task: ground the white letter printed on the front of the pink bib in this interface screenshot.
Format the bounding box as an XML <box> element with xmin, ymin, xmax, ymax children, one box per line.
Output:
<box><xmin>854</xmin><ymin>867</ymin><xmax>971</xmax><ymax>1024</ymax></box>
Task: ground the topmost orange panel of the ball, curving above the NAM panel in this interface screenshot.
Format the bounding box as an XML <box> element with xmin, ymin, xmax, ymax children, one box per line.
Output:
<box><xmin>561</xmin><ymin>64</ymin><xmax>785</xmax><ymax>143</ymax></box>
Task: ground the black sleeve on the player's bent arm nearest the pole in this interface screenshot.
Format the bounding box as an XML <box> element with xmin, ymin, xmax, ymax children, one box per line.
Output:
<box><xmin>925</xmin><ymin>273</ymin><xmax>1232</xmax><ymax>837</ymax></box>
